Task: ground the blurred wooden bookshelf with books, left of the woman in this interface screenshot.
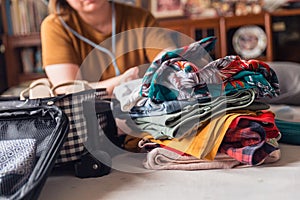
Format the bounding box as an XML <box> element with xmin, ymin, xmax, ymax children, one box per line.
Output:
<box><xmin>0</xmin><ymin>0</ymin><xmax>47</xmax><ymax>87</ymax></box>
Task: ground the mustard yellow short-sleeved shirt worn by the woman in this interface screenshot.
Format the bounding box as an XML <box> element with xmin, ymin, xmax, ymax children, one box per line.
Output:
<box><xmin>41</xmin><ymin>3</ymin><xmax>173</xmax><ymax>81</ymax></box>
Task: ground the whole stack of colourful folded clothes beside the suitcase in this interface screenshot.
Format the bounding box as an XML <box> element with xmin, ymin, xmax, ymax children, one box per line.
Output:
<box><xmin>115</xmin><ymin>37</ymin><xmax>280</xmax><ymax>170</ymax></box>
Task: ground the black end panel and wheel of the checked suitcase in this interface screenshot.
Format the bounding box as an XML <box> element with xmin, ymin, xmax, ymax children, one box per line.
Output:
<box><xmin>64</xmin><ymin>100</ymin><xmax>116</xmax><ymax>178</ymax></box>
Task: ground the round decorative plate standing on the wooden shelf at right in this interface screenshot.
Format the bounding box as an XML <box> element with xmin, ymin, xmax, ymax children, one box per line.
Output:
<box><xmin>232</xmin><ymin>25</ymin><xmax>267</xmax><ymax>59</ymax></box>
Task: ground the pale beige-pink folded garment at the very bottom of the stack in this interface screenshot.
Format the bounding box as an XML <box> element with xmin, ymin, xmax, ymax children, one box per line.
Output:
<box><xmin>143</xmin><ymin>148</ymin><xmax>240</xmax><ymax>170</ymax></box>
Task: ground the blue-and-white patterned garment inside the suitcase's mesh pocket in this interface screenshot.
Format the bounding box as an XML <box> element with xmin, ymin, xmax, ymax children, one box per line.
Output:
<box><xmin>0</xmin><ymin>139</ymin><xmax>36</xmax><ymax>196</ymax></box>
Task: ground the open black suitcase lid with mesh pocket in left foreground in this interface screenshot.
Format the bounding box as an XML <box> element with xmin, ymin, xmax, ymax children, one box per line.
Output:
<box><xmin>0</xmin><ymin>104</ymin><xmax>69</xmax><ymax>200</ymax></box>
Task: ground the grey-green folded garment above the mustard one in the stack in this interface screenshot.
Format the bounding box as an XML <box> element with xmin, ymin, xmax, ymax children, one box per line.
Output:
<box><xmin>134</xmin><ymin>90</ymin><xmax>255</xmax><ymax>139</ymax></box>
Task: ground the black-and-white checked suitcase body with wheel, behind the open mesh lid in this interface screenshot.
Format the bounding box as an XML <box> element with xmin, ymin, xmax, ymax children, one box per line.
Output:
<box><xmin>0</xmin><ymin>94</ymin><xmax>121</xmax><ymax>178</ymax></box>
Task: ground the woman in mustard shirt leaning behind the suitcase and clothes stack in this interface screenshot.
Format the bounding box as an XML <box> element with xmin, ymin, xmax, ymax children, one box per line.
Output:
<box><xmin>41</xmin><ymin>0</ymin><xmax>174</xmax><ymax>94</ymax></box>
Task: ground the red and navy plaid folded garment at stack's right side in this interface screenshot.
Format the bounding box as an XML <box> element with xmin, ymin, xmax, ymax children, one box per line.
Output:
<box><xmin>219</xmin><ymin>112</ymin><xmax>281</xmax><ymax>165</ymax></box>
